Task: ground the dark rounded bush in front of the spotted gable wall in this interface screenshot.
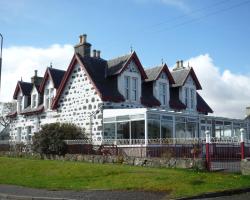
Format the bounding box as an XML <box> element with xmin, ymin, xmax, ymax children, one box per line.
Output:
<box><xmin>32</xmin><ymin>123</ymin><xmax>85</xmax><ymax>156</ymax></box>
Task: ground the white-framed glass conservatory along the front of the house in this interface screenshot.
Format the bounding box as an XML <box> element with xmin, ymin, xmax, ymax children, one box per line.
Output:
<box><xmin>103</xmin><ymin>108</ymin><xmax>250</xmax><ymax>145</ymax></box>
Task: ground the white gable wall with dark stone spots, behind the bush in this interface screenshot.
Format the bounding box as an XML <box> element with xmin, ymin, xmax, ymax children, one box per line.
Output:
<box><xmin>58</xmin><ymin>64</ymin><xmax>103</xmax><ymax>139</ymax></box>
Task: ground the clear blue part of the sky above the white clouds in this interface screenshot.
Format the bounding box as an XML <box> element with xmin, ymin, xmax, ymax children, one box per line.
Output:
<box><xmin>0</xmin><ymin>0</ymin><xmax>250</xmax><ymax>73</ymax></box>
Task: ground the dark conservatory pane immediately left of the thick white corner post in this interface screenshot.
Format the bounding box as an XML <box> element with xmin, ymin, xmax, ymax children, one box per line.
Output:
<box><xmin>131</xmin><ymin>120</ymin><xmax>145</xmax><ymax>139</ymax></box>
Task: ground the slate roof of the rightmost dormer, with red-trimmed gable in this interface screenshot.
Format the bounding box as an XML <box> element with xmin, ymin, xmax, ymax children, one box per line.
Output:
<box><xmin>171</xmin><ymin>67</ymin><xmax>202</xmax><ymax>90</ymax></box>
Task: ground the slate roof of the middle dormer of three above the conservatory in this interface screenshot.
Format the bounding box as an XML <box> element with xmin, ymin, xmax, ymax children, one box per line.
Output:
<box><xmin>145</xmin><ymin>64</ymin><xmax>175</xmax><ymax>84</ymax></box>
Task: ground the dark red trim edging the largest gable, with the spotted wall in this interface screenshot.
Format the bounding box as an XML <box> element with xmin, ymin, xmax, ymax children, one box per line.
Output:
<box><xmin>52</xmin><ymin>54</ymin><xmax>103</xmax><ymax>109</ymax></box>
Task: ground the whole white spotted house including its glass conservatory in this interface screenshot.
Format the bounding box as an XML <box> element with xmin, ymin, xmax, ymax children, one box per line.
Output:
<box><xmin>6</xmin><ymin>35</ymin><xmax>249</xmax><ymax>145</ymax></box>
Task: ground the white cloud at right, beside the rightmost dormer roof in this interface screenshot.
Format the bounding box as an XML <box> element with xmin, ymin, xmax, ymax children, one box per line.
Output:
<box><xmin>185</xmin><ymin>54</ymin><xmax>250</xmax><ymax>118</ymax></box>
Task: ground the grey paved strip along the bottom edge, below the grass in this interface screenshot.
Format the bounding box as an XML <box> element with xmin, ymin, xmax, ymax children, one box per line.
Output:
<box><xmin>0</xmin><ymin>185</ymin><xmax>167</xmax><ymax>200</ymax></box>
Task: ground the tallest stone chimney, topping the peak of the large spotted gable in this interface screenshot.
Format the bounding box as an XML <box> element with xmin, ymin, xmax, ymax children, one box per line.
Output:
<box><xmin>74</xmin><ymin>34</ymin><xmax>91</xmax><ymax>57</ymax></box>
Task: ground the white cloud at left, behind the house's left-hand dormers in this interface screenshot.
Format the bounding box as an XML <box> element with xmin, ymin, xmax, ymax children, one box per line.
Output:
<box><xmin>0</xmin><ymin>44</ymin><xmax>73</xmax><ymax>102</ymax></box>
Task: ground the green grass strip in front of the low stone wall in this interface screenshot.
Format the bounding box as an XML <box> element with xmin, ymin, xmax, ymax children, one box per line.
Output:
<box><xmin>0</xmin><ymin>157</ymin><xmax>250</xmax><ymax>197</ymax></box>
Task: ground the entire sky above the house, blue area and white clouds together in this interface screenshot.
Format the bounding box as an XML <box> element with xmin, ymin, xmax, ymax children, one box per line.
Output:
<box><xmin>0</xmin><ymin>0</ymin><xmax>250</xmax><ymax>118</ymax></box>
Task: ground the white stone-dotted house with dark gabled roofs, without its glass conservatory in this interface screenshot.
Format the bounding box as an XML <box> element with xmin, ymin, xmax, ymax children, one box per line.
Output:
<box><xmin>8</xmin><ymin>35</ymin><xmax>230</xmax><ymax>143</ymax></box>
